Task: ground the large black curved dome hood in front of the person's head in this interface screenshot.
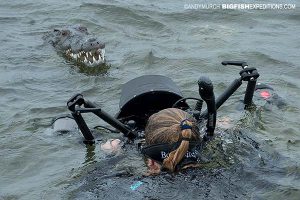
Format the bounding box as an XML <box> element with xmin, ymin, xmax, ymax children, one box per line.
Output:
<box><xmin>116</xmin><ymin>75</ymin><xmax>189</xmax><ymax>129</ymax></box>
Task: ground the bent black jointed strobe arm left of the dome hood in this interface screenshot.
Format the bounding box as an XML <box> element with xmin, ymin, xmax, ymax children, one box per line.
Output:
<box><xmin>67</xmin><ymin>94</ymin><xmax>136</xmax><ymax>143</ymax></box>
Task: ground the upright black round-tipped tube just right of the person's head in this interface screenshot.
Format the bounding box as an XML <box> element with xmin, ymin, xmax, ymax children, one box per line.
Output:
<box><xmin>198</xmin><ymin>77</ymin><xmax>217</xmax><ymax>137</ymax></box>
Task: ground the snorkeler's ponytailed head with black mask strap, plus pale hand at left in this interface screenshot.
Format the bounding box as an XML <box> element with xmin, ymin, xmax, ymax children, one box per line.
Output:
<box><xmin>101</xmin><ymin>108</ymin><xmax>202</xmax><ymax>175</ymax></box>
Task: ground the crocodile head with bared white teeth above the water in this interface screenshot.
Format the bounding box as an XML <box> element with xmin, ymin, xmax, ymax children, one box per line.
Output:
<box><xmin>43</xmin><ymin>25</ymin><xmax>105</xmax><ymax>67</ymax></box>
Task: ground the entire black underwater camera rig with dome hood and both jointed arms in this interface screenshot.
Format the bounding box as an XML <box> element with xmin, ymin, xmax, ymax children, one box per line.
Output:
<box><xmin>67</xmin><ymin>61</ymin><xmax>259</xmax><ymax>144</ymax></box>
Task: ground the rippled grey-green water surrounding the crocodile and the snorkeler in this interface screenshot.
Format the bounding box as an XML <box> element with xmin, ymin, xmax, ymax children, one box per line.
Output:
<box><xmin>0</xmin><ymin>0</ymin><xmax>300</xmax><ymax>199</ymax></box>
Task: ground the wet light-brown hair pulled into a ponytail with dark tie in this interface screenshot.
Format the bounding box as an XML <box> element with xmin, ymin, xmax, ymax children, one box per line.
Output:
<box><xmin>145</xmin><ymin>108</ymin><xmax>201</xmax><ymax>172</ymax></box>
